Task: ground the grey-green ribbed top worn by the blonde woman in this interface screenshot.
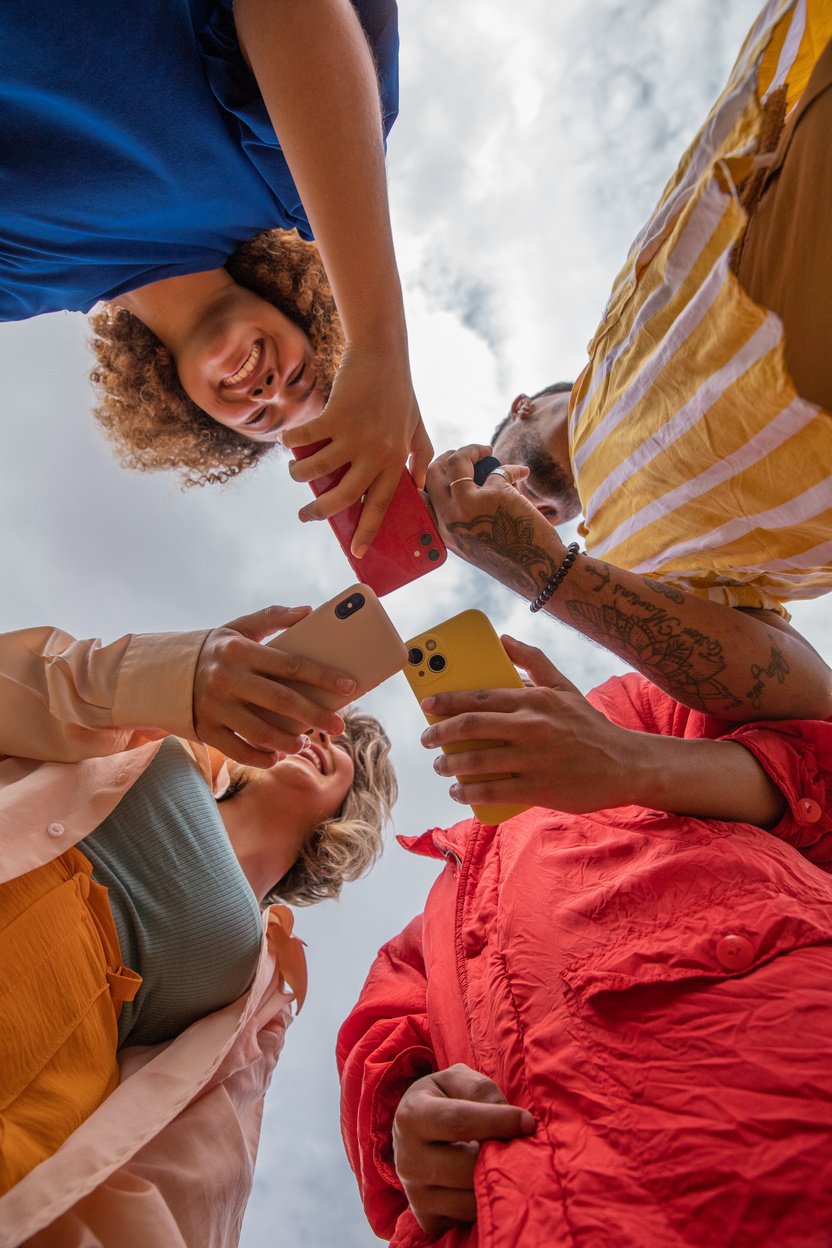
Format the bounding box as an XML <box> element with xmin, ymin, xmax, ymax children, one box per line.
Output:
<box><xmin>79</xmin><ymin>736</ymin><xmax>262</xmax><ymax>1046</ymax></box>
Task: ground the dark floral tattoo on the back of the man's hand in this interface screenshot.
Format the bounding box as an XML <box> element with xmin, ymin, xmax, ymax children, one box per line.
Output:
<box><xmin>449</xmin><ymin>507</ymin><xmax>559</xmax><ymax>597</ymax></box>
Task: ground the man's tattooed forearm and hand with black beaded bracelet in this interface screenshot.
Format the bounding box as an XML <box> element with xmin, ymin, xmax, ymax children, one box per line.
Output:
<box><xmin>428</xmin><ymin>446</ymin><xmax>832</xmax><ymax>723</ymax></box>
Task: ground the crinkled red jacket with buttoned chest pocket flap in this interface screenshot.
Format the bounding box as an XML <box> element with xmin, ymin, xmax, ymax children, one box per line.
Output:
<box><xmin>338</xmin><ymin>676</ymin><xmax>832</xmax><ymax>1248</ymax></box>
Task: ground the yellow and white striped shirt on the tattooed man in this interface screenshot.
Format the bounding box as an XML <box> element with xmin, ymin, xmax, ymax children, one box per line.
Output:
<box><xmin>570</xmin><ymin>0</ymin><xmax>832</xmax><ymax>607</ymax></box>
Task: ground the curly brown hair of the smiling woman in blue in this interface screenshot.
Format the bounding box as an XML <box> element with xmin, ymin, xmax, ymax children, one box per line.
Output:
<box><xmin>90</xmin><ymin>230</ymin><xmax>344</xmax><ymax>485</ymax></box>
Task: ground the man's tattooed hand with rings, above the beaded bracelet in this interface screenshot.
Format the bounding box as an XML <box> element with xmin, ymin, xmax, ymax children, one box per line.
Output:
<box><xmin>427</xmin><ymin>444</ymin><xmax>566</xmax><ymax>599</ymax></box>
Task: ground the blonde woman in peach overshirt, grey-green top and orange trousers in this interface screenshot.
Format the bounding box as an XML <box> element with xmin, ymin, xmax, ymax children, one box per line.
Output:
<box><xmin>0</xmin><ymin>609</ymin><xmax>397</xmax><ymax>1248</ymax></box>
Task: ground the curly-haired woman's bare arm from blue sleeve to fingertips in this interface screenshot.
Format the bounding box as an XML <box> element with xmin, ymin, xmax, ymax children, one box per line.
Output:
<box><xmin>235</xmin><ymin>0</ymin><xmax>432</xmax><ymax>557</ymax></box>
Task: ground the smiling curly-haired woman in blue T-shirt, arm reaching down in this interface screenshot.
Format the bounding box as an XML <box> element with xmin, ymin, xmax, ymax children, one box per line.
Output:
<box><xmin>0</xmin><ymin>0</ymin><xmax>430</xmax><ymax>553</ymax></box>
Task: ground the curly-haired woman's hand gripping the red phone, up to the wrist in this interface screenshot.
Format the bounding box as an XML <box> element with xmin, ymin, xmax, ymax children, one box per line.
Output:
<box><xmin>282</xmin><ymin>344</ymin><xmax>433</xmax><ymax>559</ymax></box>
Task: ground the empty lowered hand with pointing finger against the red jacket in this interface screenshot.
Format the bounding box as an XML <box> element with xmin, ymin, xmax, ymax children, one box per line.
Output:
<box><xmin>393</xmin><ymin>1062</ymin><xmax>535</xmax><ymax>1236</ymax></box>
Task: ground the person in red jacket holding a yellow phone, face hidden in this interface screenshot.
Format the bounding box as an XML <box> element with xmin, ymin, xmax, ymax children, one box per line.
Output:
<box><xmin>338</xmin><ymin>638</ymin><xmax>832</xmax><ymax>1248</ymax></box>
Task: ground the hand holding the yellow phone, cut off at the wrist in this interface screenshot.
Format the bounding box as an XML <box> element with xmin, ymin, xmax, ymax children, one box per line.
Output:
<box><xmin>422</xmin><ymin>636</ymin><xmax>639</xmax><ymax>814</ymax></box>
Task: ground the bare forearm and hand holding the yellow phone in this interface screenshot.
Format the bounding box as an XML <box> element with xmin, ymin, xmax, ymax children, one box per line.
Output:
<box><xmin>422</xmin><ymin>636</ymin><xmax>793</xmax><ymax>829</ymax></box>
